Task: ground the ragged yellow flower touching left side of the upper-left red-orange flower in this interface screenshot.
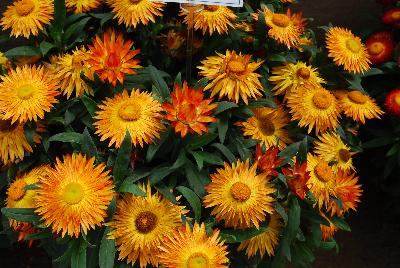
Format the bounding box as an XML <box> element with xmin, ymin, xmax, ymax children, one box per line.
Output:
<box><xmin>50</xmin><ymin>47</ymin><xmax>94</xmax><ymax>98</ymax></box>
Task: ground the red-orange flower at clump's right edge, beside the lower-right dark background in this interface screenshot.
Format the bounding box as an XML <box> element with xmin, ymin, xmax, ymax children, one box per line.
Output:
<box><xmin>328</xmin><ymin>169</ymin><xmax>362</xmax><ymax>216</ymax></box>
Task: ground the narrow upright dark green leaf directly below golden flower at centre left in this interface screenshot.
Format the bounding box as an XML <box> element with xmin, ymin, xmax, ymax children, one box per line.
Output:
<box><xmin>113</xmin><ymin>131</ymin><xmax>132</xmax><ymax>182</ymax></box>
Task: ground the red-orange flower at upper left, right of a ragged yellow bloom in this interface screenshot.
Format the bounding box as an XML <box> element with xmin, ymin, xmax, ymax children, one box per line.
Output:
<box><xmin>89</xmin><ymin>31</ymin><xmax>141</xmax><ymax>86</ymax></box>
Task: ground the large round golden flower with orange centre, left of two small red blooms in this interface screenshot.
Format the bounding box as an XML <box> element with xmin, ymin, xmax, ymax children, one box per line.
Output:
<box><xmin>203</xmin><ymin>160</ymin><xmax>275</xmax><ymax>229</ymax></box>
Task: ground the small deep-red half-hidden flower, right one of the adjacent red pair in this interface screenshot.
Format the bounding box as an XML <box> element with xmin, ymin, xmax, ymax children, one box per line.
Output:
<box><xmin>282</xmin><ymin>161</ymin><xmax>310</xmax><ymax>199</ymax></box>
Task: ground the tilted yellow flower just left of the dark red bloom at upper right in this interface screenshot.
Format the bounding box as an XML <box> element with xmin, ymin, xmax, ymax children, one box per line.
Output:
<box><xmin>326</xmin><ymin>27</ymin><xmax>371</xmax><ymax>73</ymax></box>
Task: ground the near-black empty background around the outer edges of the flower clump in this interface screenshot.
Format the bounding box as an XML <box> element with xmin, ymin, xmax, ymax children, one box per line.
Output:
<box><xmin>0</xmin><ymin>0</ymin><xmax>400</xmax><ymax>268</ymax></box>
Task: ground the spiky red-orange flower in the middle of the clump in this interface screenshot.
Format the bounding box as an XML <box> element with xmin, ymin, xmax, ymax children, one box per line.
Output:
<box><xmin>162</xmin><ymin>81</ymin><xmax>217</xmax><ymax>137</ymax></box>
